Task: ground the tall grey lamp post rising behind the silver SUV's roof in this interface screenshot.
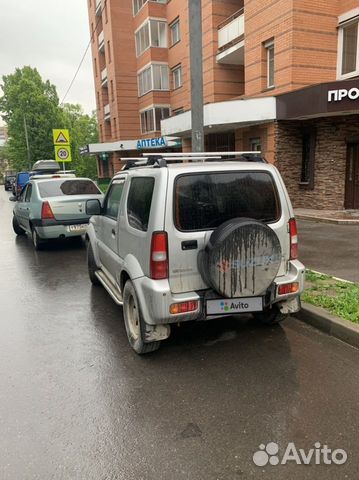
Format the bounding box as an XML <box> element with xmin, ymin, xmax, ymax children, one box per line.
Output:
<box><xmin>188</xmin><ymin>0</ymin><xmax>204</xmax><ymax>152</ymax></box>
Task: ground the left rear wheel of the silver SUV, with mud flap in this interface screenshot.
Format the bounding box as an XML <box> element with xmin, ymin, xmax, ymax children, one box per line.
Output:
<box><xmin>123</xmin><ymin>280</ymin><xmax>161</xmax><ymax>355</ymax></box>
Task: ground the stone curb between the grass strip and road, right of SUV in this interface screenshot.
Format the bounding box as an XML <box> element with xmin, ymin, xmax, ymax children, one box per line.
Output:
<box><xmin>294</xmin><ymin>302</ymin><xmax>359</xmax><ymax>348</ymax></box>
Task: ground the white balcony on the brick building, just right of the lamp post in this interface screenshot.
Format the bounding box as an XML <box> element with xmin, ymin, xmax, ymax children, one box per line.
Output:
<box><xmin>216</xmin><ymin>8</ymin><xmax>244</xmax><ymax>65</ymax></box>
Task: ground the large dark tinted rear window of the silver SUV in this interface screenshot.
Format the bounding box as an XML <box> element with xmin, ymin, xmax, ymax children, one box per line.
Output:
<box><xmin>174</xmin><ymin>172</ymin><xmax>280</xmax><ymax>231</ymax></box>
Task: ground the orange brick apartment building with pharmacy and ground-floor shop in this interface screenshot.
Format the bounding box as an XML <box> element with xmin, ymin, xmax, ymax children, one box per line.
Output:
<box><xmin>88</xmin><ymin>0</ymin><xmax>359</xmax><ymax>209</ymax></box>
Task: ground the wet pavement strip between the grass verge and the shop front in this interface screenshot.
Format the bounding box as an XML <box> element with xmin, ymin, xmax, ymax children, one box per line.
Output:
<box><xmin>298</xmin><ymin>220</ymin><xmax>359</xmax><ymax>282</ymax></box>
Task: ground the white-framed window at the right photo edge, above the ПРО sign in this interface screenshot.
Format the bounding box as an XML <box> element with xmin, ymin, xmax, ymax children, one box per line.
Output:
<box><xmin>338</xmin><ymin>20</ymin><xmax>359</xmax><ymax>78</ymax></box>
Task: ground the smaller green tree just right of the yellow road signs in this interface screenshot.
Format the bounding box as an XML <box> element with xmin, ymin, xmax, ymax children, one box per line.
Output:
<box><xmin>61</xmin><ymin>103</ymin><xmax>98</xmax><ymax>178</ymax></box>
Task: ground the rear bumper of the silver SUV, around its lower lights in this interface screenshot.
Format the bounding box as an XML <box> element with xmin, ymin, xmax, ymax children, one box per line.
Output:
<box><xmin>133</xmin><ymin>260</ymin><xmax>305</xmax><ymax>325</ymax></box>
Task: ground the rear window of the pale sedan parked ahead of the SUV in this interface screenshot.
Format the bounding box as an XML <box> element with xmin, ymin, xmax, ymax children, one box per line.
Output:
<box><xmin>38</xmin><ymin>180</ymin><xmax>101</xmax><ymax>198</ymax></box>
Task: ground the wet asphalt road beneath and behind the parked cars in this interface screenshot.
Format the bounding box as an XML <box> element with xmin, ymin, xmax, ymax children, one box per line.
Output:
<box><xmin>0</xmin><ymin>190</ymin><xmax>359</xmax><ymax>480</ymax></box>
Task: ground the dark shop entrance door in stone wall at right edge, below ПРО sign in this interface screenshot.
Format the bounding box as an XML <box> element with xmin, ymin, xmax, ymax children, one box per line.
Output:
<box><xmin>344</xmin><ymin>143</ymin><xmax>359</xmax><ymax>209</ymax></box>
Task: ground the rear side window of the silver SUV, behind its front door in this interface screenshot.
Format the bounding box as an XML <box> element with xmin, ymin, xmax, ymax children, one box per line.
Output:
<box><xmin>127</xmin><ymin>177</ymin><xmax>155</xmax><ymax>232</ymax></box>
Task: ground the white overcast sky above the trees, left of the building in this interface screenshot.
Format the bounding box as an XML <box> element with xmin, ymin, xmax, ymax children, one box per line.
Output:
<box><xmin>0</xmin><ymin>0</ymin><xmax>95</xmax><ymax>124</ymax></box>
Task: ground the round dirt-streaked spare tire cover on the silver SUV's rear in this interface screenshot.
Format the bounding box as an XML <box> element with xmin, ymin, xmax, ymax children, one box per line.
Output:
<box><xmin>200</xmin><ymin>218</ymin><xmax>282</xmax><ymax>298</ymax></box>
